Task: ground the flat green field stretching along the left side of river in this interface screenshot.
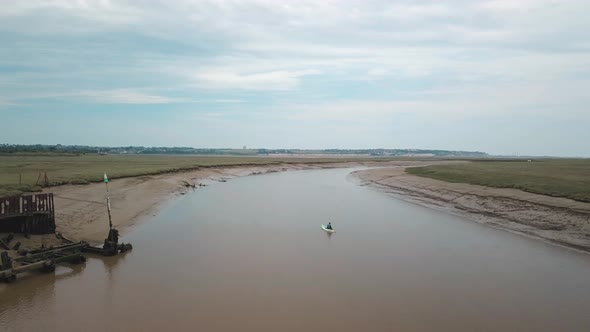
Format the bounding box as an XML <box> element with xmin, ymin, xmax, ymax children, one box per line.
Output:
<box><xmin>0</xmin><ymin>155</ymin><xmax>386</xmax><ymax>197</ymax></box>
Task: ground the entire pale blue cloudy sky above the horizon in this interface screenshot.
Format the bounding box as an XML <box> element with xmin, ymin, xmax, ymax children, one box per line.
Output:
<box><xmin>0</xmin><ymin>0</ymin><xmax>590</xmax><ymax>157</ymax></box>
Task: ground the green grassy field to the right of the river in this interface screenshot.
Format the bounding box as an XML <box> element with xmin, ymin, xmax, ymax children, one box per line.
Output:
<box><xmin>406</xmin><ymin>159</ymin><xmax>590</xmax><ymax>202</ymax></box>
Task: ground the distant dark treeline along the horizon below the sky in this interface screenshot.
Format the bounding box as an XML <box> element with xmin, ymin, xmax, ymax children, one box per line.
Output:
<box><xmin>0</xmin><ymin>144</ymin><xmax>488</xmax><ymax>158</ymax></box>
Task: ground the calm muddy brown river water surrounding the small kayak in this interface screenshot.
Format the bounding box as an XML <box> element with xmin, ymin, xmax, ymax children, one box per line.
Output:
<box><xmin>0</xmin><ymin>170</ymin><xmax>590</xmax><ymax>331</ymax></box>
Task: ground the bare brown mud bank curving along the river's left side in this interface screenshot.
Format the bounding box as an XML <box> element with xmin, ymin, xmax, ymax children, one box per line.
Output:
<box><xmin>44</xmin><ymin>160</ymin><xmax>456</xmax><ymax>244</ymax></box>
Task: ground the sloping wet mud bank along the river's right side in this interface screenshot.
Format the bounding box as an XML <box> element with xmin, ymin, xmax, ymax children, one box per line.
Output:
<box><xmin>354</xmin><ymin>167</ymin><xmax>590</xmax><ymax>252</ymax></box>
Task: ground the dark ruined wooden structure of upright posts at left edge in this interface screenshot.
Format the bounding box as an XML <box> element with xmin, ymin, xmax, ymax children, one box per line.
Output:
<box><xmin>0</xmin><ymin>193</ymin><xmax>55</xmax><ymax>234</ymax></box>
